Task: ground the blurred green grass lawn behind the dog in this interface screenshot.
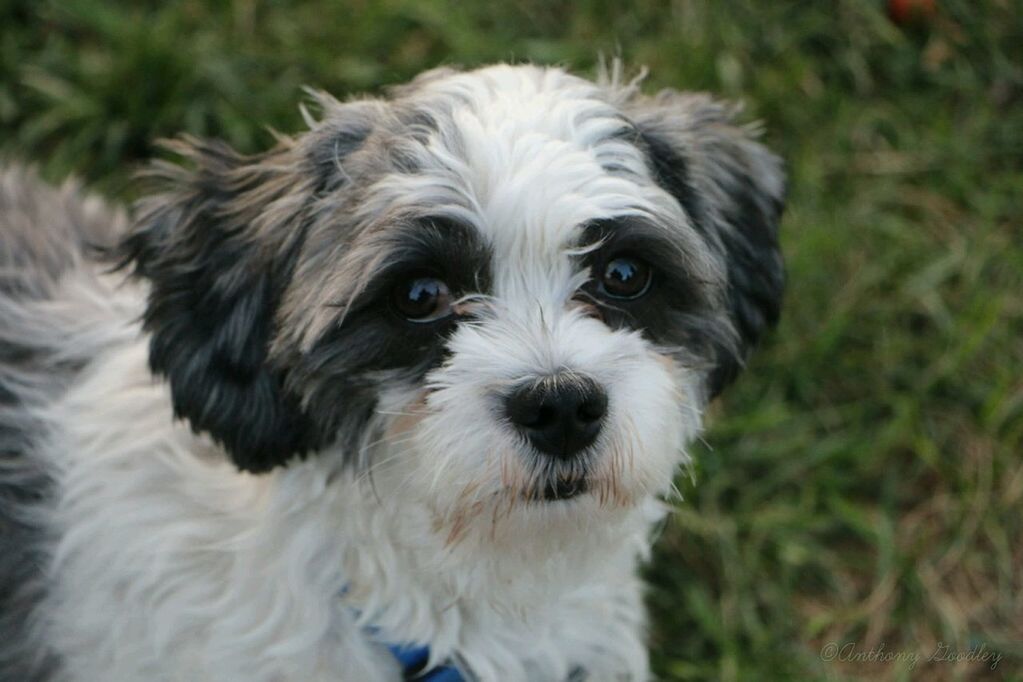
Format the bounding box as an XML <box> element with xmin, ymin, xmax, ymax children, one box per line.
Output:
<box><xmin>0</xmin><ymin>0</ymin><xmax>1023</xmax><ymax>681</ymax></box>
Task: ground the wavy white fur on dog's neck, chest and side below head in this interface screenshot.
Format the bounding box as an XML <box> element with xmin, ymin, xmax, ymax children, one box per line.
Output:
<box><xmin>37</xmin><ymin>278</ymin><xmax>661</xmax><ymax>680</ymax></box>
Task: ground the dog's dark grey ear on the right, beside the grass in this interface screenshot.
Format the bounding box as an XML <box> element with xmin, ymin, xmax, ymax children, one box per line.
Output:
<box><xmin>629</xmin><ymin>90</ymin><xmax>785</xmax><ymax>398</ymax></box>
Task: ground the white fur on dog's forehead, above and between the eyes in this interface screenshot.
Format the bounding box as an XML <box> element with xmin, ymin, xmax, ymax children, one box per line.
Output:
<box><xmin>394</xmin><ymin>65</ymin><xmax>653</xmax><ymax>245</ymax></box>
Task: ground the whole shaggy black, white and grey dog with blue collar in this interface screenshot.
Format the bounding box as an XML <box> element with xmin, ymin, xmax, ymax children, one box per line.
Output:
<box><xmin>0</xmin><ymin>64</ymin><xmax>785</xmax><ymax>682</ymax></box>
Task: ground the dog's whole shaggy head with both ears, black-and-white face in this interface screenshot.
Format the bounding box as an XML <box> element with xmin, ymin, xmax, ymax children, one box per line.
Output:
<box><xmin>125</xmin><ymin>65</ymin><xmax>783</xmax><ymax>524</ymax></box>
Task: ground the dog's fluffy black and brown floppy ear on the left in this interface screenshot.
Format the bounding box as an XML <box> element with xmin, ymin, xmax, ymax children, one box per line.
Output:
<box><xmin>121</xmin><ymin>138</ymin><xmax>321</xmax><ymax>471</ymax></box>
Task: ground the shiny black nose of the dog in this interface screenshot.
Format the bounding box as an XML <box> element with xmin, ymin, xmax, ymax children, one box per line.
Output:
<box><xmin>505</xmin><ymin>374</ymin><xmax>608</xmax><ymax>458</ymax></box>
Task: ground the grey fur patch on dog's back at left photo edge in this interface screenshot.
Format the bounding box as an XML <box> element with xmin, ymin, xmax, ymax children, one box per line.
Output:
<box><xmin>0</xmin><ymin>168</ymin><xmax>125</xmax><ymax>682</ymax></box>
